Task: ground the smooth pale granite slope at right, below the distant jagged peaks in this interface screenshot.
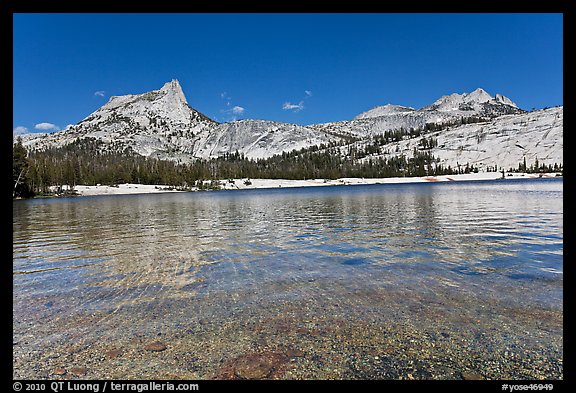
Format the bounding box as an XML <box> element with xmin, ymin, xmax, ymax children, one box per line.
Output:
<box><xmin>357</xmin><ymin>107</ymin><xmax>564</xmax><ymax>170</ymax></box>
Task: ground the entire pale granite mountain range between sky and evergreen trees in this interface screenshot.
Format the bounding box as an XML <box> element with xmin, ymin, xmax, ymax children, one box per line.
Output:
<box><xmin>21</xmin><ymin>80</ymin><xmax>563</xmax><ymax>170</ymax></box>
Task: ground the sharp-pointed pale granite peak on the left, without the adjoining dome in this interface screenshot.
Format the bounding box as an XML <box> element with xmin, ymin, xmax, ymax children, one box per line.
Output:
<box><xmin>22</xmin><ymin>80</ymin><xmax>218</xmax><ymax>158</ymax></box>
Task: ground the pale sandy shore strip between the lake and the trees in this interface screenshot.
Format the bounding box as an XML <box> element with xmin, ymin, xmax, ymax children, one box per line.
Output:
<box><xmin>66</xmin><ymin>172</ymin><xmax>556</xmax><ymax>196</ymax></box>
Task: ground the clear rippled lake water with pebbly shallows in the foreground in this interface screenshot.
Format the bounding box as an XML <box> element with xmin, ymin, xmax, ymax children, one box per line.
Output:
<box><xmin>13</xmin><ymin>179</ymin><xmax>563</xmax><ymax>379</ymax></box>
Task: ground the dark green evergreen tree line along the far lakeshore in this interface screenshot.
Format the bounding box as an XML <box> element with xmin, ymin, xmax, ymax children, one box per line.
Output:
<box><xmin>13</xmin><ymin>133</ymin><xmax>562</xmax><ymax>197</ymax></box>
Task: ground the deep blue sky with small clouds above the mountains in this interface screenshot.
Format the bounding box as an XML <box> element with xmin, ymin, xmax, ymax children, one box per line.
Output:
<box><xmin>13</xmin><ymin>13</ymin><xmax>563</xmax><ymax>132</ymax></box>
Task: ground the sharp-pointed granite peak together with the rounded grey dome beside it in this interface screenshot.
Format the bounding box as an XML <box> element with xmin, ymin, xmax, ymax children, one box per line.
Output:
<box><xmin>23</xmin><ymin>80</ymin><xmax>334</xmax><ymax>162</ymax></box>
